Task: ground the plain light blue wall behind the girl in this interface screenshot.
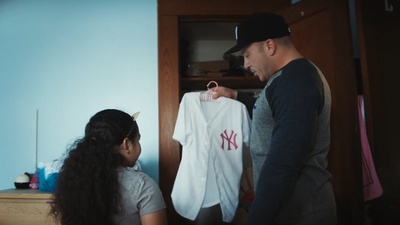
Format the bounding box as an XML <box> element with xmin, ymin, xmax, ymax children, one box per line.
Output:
<box><xmin>0</xmin><ymin>0</ymin><xmax>158</xmax><ymax>189</ymax></box>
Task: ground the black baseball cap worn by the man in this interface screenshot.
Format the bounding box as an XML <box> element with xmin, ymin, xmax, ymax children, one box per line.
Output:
<box><xmin>224</xmin><ymin>13</ymin><xmax>290</xmax><ymax>55</ymax></box>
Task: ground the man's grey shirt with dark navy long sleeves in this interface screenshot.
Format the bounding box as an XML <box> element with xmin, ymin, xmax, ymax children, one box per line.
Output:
<box><xmin>237</xmin><ymin>59</ymin><xmax>336</xmax><ymax>225</ymax></box>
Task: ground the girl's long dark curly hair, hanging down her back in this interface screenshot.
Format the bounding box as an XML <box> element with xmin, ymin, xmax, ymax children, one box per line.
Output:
<box><xmin>50</xmin><ymin>109</ymin><xmax>138</xmax><ymax>225</ymax></box>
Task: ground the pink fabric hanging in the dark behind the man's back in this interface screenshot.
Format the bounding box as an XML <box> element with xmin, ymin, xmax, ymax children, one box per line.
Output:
<box><xmin>358</xmin><ymin>95</ymin><xmax>383</xmax><ymax>202</ymax></box>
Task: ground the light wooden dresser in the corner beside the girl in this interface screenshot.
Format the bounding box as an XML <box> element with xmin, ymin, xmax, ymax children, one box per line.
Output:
<box><xmin>0</xmin><ymin>188</ymin><xmax>55</xmax><ymax>225</ymax></box>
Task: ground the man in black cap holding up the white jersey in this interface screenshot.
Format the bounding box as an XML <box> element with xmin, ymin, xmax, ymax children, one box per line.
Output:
<box><xmin>213</xmin><ymin>13</ymin><xmax>336</xmax><ymax>225</ymax></box>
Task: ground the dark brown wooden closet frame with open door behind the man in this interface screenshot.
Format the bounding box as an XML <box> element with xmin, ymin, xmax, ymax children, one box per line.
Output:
<box><xmin>158</xmin><ymin>0</ymin><xmax>368</xmax><ymax>225</ymax></box>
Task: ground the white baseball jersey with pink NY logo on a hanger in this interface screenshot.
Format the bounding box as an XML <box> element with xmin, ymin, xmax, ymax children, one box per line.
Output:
<box><xmin>171</xmin><ymin>92</ymin><xmax>250</xmax><ymax>222</ymax></box>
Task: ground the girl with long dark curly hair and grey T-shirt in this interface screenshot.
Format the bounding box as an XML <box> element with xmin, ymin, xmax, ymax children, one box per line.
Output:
<box><xmin>50</xmin><ymin>109</ymin><xmax>167</xmax><ymax>225</ymax></box>
